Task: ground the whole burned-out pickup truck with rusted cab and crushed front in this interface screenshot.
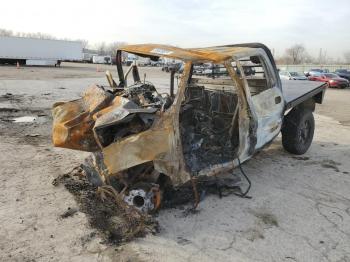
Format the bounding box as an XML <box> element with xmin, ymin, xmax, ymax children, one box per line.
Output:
<box><xmin>53</xmin><ymin>43</ymin><xmax>326</xmax><ymax>212</ymax></box>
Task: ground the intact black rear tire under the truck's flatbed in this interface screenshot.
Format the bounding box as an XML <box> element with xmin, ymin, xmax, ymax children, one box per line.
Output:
<box><xmin>281</xmin><ymin>109</ymin><xmax>315</xmax><ymax>155</ymax></box>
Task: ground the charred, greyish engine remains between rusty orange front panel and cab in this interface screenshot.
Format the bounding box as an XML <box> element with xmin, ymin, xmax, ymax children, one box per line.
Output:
<box><xmin>94</xmin><ymin>83</ymin><xmax>172</xmax><ymax>147</ymax></box>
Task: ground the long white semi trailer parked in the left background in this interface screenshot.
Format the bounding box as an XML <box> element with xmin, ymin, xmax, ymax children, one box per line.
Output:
<box><xmin>0</xmin><ymin>36</ymin><xmax>83</xmax><ymax>66</ymax></box>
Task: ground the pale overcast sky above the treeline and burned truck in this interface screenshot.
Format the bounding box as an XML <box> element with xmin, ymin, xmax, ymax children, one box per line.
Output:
<box><xmin>0</xmin><ymin>0</ymin><xmax>350</xmax><ymax>58</ymax></box>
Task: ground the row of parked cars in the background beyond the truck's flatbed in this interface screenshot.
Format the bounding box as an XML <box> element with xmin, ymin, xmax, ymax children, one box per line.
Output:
<box><xmin>279</xmin><ymin>69</ymin><xmax>350</xmax><ymax>88</ymax></box>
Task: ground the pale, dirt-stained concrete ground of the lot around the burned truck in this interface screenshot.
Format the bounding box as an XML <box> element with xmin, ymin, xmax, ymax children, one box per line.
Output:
<box><xmin>0</xmin><ymin>63</ymin><xmax>350</xmax><ymax>262</ymax></box>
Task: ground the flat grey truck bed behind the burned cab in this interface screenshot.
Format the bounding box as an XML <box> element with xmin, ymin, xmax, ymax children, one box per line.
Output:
<box><xmin>282</xmin><ymin>80</ymin><xmax>327</xmax><ymax>110</ymax></box>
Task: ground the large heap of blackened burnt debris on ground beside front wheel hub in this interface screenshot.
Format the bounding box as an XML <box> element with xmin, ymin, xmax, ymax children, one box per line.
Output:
<box><xmin>53</xmin><ymin>167</ymin><xmax>158</xmax><ymax>244</ymax></box>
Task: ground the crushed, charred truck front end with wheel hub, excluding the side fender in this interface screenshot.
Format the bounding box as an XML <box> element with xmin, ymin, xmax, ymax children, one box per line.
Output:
<box><xmin>53</xmin><ymin>82</ymin><xmax>172</xmax><ymax>212</ymax></box>
